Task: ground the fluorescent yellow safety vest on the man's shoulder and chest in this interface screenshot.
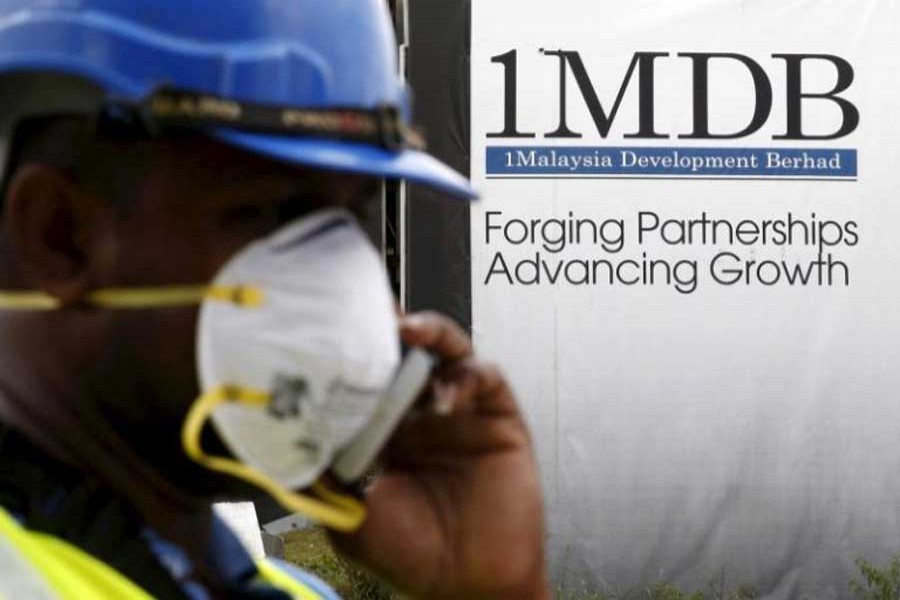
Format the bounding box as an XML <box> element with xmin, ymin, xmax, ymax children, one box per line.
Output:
<box><xmin>0</xmin><ymin>508</ymin><xmax>322</xmax><ymax>600</ymax></box>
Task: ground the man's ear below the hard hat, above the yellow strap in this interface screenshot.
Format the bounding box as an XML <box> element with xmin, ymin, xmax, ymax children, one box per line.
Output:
<box><xmin>4</xmin><ymin>164</ymin><xmax>98</xmax><ymax>304</ymax></box>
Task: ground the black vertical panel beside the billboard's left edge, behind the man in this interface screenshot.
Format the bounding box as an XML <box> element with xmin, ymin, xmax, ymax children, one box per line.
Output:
<box><xmin>406</xmin><ymin>0</ymin><xmax>472</xmax><ymax>329</ymax></box>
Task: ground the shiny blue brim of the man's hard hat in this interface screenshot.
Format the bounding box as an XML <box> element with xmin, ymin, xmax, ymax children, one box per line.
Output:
<box><xmin>211</xmin><ymin>129</ymin><xmax>478</xmax><ymax>200</ymax></box>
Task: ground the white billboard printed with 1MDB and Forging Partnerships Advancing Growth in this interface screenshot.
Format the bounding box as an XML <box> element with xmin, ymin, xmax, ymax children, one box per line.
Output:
<box><xmin>471</xmin><ymin>0</ymin><xmax>900</xmax><ymax>600</ymax></box>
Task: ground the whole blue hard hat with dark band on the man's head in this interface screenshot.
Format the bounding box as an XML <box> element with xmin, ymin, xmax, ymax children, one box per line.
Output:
<box><xmin>0</xmin><ymin>0</ymin><xmax>476</xmax><ymax>198</ymax></box>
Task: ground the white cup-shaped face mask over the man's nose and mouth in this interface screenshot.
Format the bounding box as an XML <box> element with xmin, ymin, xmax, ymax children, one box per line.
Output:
<box><xmin>186</xmin><ymin>209</ymin><xmax>410</xmax><ymax>528</ymax></box>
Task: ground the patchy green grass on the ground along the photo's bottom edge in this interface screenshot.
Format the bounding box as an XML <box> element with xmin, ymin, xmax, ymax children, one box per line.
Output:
<box><xmin>283</xmin><ymin>529</ymin><xmax>900</xmax><ymax>600</ymax></box>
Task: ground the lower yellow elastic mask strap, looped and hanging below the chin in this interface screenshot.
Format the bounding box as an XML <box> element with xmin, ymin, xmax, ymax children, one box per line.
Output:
<box><xmin>181</xmin><ymin>387</ymin><xmax>366</xmax><ymax>532</ymax></box>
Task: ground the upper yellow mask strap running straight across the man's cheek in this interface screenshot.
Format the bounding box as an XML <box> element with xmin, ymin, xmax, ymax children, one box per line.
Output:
<box><xmin>0</xmin><ymin>286</ymin><xmax>264</xmax><ymax>311</ymax></box>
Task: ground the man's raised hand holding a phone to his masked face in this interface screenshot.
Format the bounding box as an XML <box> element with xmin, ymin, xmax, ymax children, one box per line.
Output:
<box><xmin>337</xmin><ymin>314</ymin><xmax>550</xmax><ymax>600</ymax></box>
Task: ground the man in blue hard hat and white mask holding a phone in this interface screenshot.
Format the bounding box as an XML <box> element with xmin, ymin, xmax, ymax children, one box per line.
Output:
<box><xmin>0</xmin><ymin>0</ymin><xmax>549</xmax><ymax>600</ymax></box>
